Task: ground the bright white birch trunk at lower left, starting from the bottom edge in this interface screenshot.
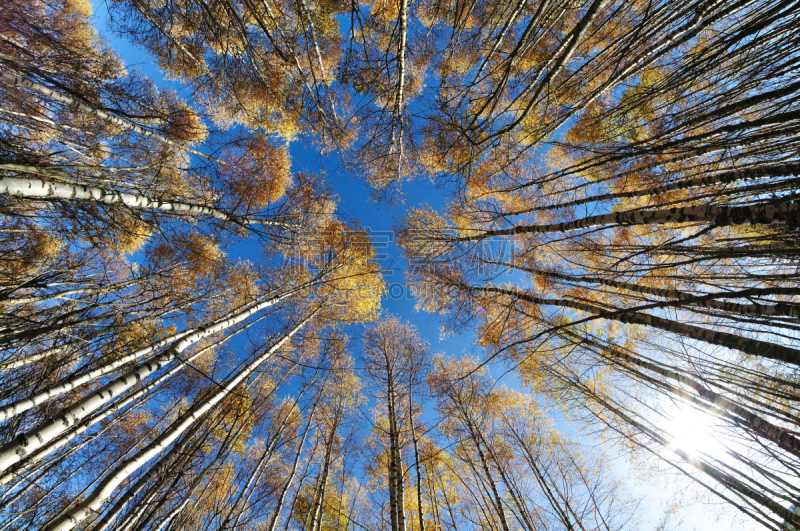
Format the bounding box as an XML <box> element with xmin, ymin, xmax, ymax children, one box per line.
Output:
<box><xmin>46</xmin><ymin>310</ymin><xmax>318</xmax><ymax>531</ymax></box>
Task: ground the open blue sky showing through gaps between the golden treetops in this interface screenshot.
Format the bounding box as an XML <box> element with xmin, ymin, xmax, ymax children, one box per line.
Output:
<box><xmin>93</xmin><ymin>0</ymin><xmax>760</xmax><ymax>531</ymax></box>
